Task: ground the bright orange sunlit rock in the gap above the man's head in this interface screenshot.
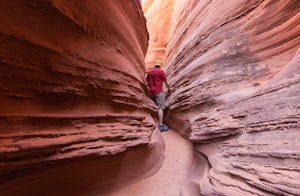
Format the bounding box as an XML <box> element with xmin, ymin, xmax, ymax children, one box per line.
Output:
<box><xmin>143</xmin><ymin>0</ymin><xmax>175</xmax><ymax>70</ymax></box>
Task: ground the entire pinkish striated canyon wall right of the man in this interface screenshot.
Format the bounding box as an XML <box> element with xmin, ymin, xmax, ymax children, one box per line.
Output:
<box><xmin>164</xmin><ymin>0</ymin><xmax>300</xmax><ymax>195</ymax></box>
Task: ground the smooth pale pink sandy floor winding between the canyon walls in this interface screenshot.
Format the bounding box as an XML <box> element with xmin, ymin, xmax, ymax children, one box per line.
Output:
<box><xmin>109</xmin><ymin>129</ymin><xmax>193</xmax><ymax>196</ymax></box>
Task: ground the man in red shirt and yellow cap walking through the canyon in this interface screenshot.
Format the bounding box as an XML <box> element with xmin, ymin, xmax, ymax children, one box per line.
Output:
<box><xmin>147</xmin><ymin>60</ymin><xmax>170</xmax><ymax>132</ymax></box>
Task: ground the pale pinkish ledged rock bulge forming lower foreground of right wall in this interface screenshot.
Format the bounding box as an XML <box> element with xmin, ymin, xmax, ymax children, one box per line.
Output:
<box><xmin>190</xmin><ymin>50</ymin><xmax>300</xmax><ymax>195</ymax></box>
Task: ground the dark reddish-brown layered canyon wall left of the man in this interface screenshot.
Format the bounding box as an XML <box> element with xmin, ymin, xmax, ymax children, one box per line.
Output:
<box><xmin>0</xmin><ymin>0</ymin><xmax>163</xmax><ymax>195</ymax></box>
